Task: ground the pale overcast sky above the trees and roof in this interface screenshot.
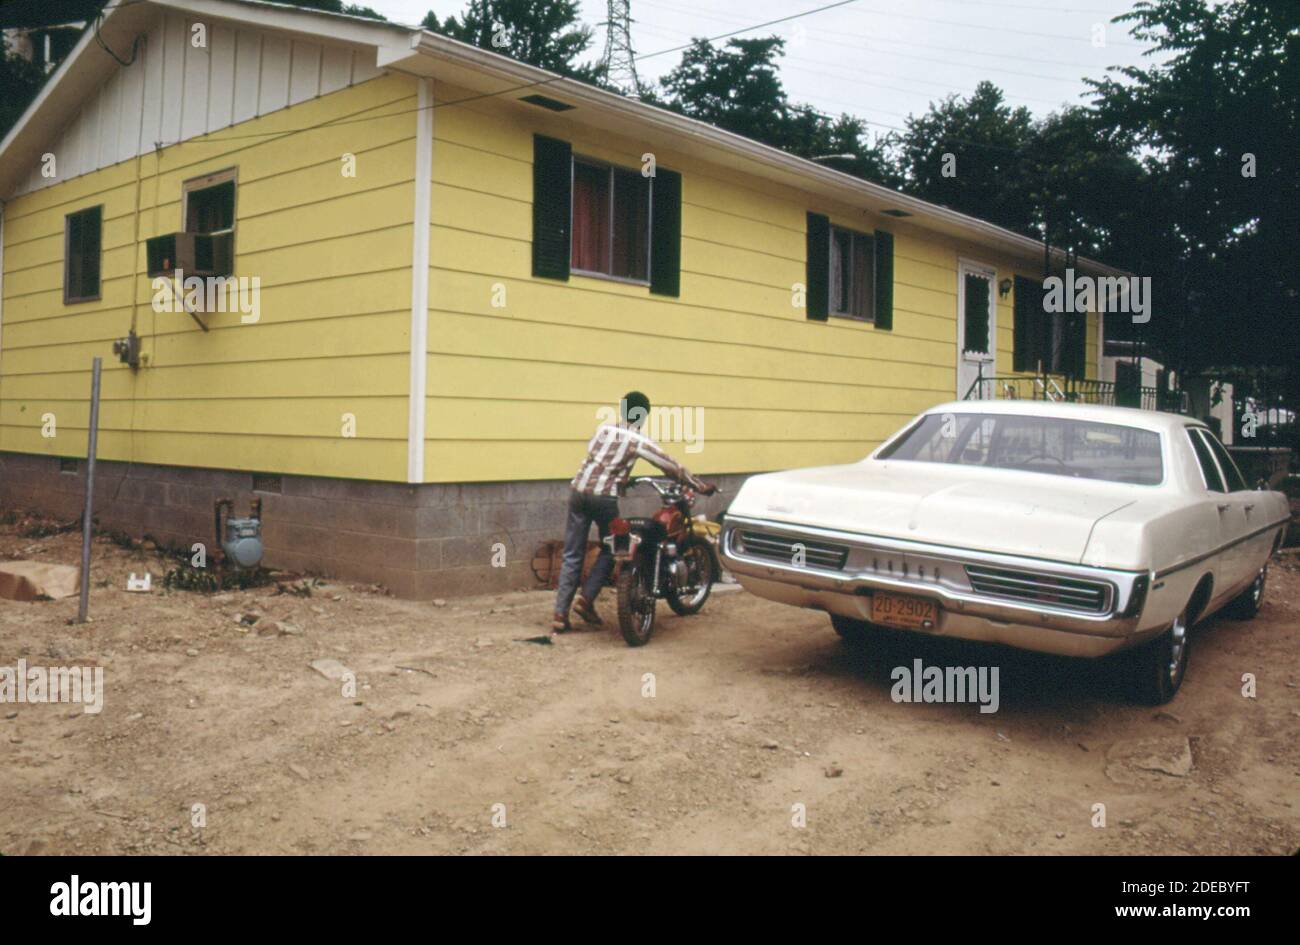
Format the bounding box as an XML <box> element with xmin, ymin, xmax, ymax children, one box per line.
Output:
<box><xmin>364</xmin><ymin>0</ymin><xmax>1170</xmax><ymax>136</ymax></box>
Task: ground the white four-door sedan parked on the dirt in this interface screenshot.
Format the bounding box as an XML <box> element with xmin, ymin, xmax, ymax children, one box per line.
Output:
<box><xmin>720</xmin><ymin>400</ymin><xmax>1290</xmax><ymax>703</ymax></box>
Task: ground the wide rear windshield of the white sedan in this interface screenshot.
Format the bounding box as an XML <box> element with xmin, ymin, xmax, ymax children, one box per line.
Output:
<box><xmin>878</xmin><ymin>413</ymin><xmax>1165</xmax><ymax>486</ymax></box>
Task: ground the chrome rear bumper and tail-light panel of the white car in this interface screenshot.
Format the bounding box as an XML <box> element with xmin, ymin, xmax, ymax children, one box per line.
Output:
<box><xmin>720</xmin><ymin>516</ymin><xmax>1151</xmax><ymax>656</ymax></box>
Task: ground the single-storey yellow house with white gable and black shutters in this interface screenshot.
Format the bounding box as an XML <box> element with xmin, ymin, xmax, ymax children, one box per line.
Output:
<box><xmin>0</xmin><ymin>0</ymin><xmax>1118</xmax><ymax>597</ymax></box>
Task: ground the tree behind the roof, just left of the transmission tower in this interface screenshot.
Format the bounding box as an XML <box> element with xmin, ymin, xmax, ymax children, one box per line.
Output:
<box><xmin>423</xmin><ymin>0</ymin><xmax>598</xmax><ymax>82</ymax></box>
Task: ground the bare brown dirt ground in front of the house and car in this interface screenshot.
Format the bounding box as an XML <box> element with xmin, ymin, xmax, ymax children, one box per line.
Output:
<box><xmin>0</xmin><ymin>526</ymin><xmax>1300</xmax><ymax>854</ymax></box>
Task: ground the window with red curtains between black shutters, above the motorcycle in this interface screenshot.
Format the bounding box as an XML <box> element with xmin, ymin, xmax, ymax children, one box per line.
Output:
<box><xmin>572</xmin><ymin>159</ymin><xmax>650</xmax><ymax>282</ymax></box>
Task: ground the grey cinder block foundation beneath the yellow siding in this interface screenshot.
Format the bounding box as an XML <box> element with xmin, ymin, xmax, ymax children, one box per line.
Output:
<box><xmin>0</xmin><ymin>452</ymin><xmax>745</xmax><ymax>599</ymax></box>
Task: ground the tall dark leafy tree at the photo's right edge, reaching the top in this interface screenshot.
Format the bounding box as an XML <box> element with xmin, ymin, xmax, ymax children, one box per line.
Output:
<box><xmin>1091</xmin><ymin>0</ymin><xmax>1300</xmax><ymax>376</ymax></box>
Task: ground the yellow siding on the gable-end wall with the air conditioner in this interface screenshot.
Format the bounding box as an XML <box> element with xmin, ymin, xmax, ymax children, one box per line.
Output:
<box><xmin>0</xmin><ymin>75</ymin><xmax>415</xmax><ymax>481</ymax></box>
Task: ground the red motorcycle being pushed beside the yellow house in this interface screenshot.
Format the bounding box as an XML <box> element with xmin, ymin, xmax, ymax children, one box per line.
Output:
<box><xmin>605</xmin><ymin>476</ymin><xmax>720</xmax><ymax>646</ymax></box>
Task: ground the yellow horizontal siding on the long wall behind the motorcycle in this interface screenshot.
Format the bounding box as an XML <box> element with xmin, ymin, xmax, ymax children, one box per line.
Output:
<box><xmin>425</xmin><ymin>86</ymin><xmax>1086</xmax><ymax>481</ymax></box>
